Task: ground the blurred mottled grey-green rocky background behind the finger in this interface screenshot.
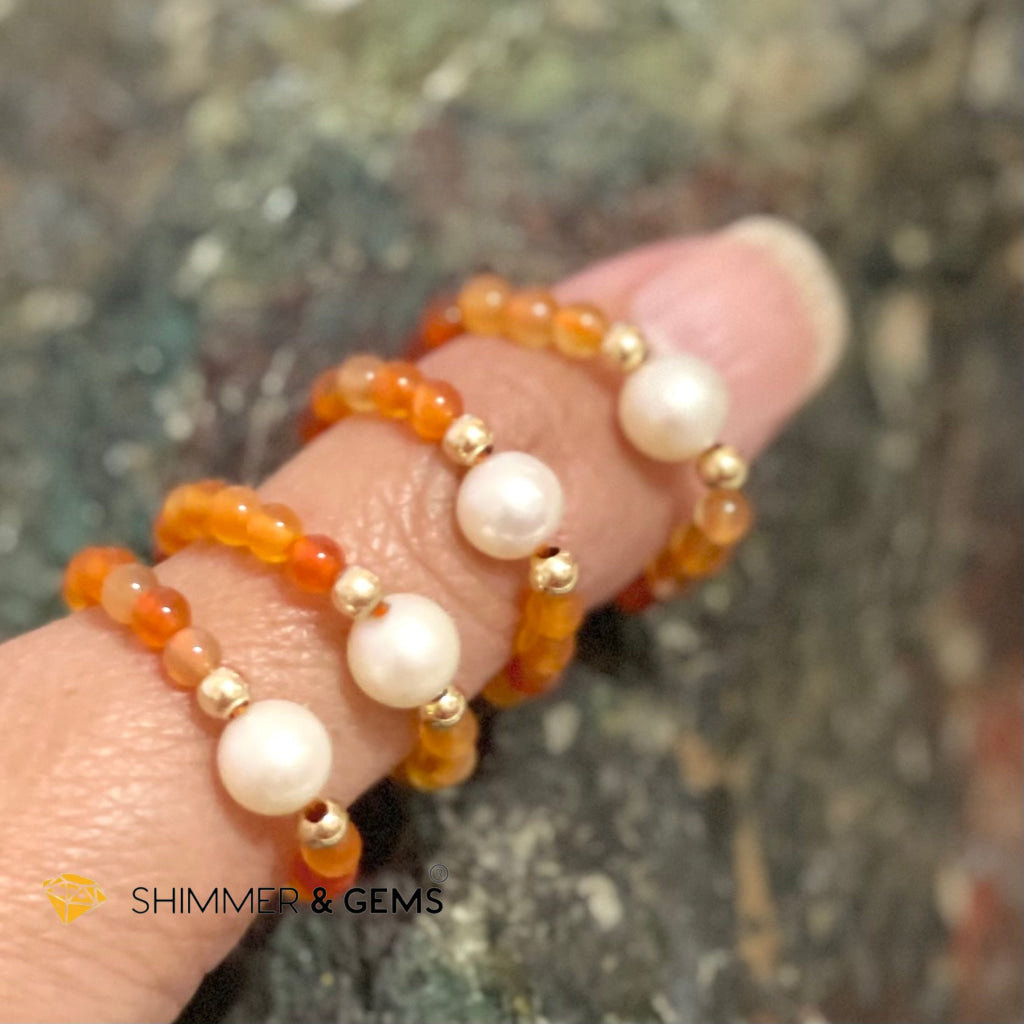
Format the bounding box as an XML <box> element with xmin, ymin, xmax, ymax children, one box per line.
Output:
<box><xmin>0</xmin><ymin>0</ymin><xmax>1024</xmax><ymax>1024</ymax></box>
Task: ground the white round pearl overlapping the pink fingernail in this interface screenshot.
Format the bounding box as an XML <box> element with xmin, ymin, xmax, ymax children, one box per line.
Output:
<box><xmin>618</xmin><ymin>354</ymin><xmax>729</xmax><ymax>462</ymax></box>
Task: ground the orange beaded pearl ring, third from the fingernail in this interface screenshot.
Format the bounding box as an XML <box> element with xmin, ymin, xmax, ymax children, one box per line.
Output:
<box><xmin>155</xmin><ymin>480</ymin><xmax>478</xmax><ymax>790</ymax></box>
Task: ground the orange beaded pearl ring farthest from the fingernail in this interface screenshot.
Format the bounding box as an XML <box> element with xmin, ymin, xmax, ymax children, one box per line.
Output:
<box><xmin>63</xmin><ymin>548</ymin><xmax>362</xmax><ymax>898</ymax></box>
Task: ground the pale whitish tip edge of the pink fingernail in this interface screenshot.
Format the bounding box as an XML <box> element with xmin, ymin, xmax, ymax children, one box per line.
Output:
<box><xmin>721</xmin><ymin>216</ymin><xmax>850</xmax><ymax>388</ymax></box>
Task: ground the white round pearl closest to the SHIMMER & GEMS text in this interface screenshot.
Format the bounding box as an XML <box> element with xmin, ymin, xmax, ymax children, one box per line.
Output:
<box><xmin>217</xmin><ymin>700</ymin><xmax>331</xmax><ymax>814</ymax></box>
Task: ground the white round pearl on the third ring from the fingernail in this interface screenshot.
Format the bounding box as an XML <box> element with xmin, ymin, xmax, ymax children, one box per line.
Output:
<box><xmin>348</xmin><ymin>594</ymin><xmax>461</xmax><ymax>708</ymax></box>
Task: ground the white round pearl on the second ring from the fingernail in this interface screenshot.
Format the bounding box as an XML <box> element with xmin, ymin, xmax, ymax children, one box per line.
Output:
<box><xmin>456</xmin><ymin>452</ymin><xmax>564</xmax><ymax>558</ymax></box>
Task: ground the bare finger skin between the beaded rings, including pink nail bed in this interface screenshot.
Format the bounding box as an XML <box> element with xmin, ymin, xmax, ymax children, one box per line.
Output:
<box><xmin>0</xmin><ymin>228</ymin><xmax>837</xmax><ymax>1021</ymax></box>
